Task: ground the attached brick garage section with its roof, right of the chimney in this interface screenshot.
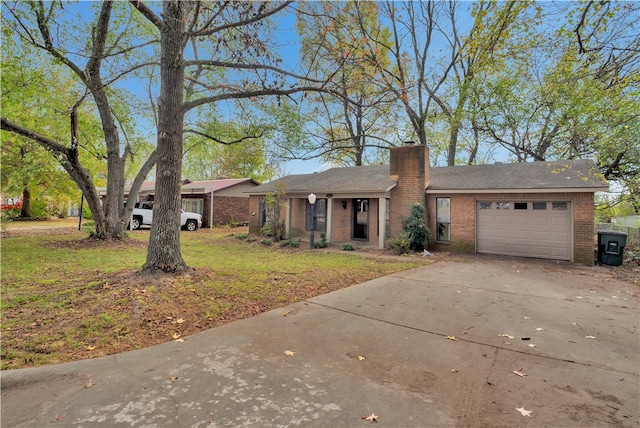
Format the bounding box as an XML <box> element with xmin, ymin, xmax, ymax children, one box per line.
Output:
<box><xmin>426</xmin><ymin>160</ymin><xmax>608</xmax><ymax>265</ymax></box>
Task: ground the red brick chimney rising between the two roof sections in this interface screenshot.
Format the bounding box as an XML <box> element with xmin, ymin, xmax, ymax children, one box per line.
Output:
<box><xmin>389</xmin><ymin>142</ymin><xmax>430</xmax><ymax>236</ymax></box>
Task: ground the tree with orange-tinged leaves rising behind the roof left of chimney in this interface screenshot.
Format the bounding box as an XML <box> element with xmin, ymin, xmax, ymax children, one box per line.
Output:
<box><xmin>298</xmin><ymin>2</ymin><xmax>396</xmax><ymax>166</ymax></box>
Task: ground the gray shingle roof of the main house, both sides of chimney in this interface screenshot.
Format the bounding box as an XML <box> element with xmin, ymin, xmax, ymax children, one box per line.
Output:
<box><xmin>248</xmin><ymin>160</ymin><xmax>609</xmax><ymax>194</ymax></box>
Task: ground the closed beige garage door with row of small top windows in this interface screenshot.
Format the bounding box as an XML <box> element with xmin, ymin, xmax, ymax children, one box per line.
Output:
<box><xmin>476</xmin><ymin>201</ymin><xmax>571</xmax><ymax>260</ymax></box>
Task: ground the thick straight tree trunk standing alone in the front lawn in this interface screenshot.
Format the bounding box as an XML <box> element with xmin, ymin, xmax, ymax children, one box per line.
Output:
<box><xmin>143</xmin><ymin>0</ymin><xmax>192</xmax><ymax>273</ymax></box>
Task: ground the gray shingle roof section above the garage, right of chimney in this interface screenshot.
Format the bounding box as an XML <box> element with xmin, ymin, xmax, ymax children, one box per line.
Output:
<box><xmin>428</xmin><ymin>159</ymin><xmax>609</xmax><ymax>191</ymax></box>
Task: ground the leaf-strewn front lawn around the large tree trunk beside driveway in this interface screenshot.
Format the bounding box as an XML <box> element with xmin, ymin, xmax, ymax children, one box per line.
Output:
<box><xmin>0</xmin><ymin>229</ymin><xmax>428</xmax><ymax>369</ymax></box>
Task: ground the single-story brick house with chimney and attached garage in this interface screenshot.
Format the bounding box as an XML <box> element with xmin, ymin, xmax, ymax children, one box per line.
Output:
<box><xmin>249</xmin><ymin>145</ymin><xmax>609</xmax><ymax>264</ymax></box>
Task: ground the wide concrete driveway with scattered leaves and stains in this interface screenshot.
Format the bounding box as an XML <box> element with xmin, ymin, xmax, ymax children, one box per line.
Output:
<box><xmin>0</xmin><ymin>252</ymin><xmax>640</xmax><ymax>427</ymax></box>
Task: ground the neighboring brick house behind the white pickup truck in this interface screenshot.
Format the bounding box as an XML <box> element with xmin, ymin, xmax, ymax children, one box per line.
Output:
<box><xmin>101</xmin><ymin>178</ymin><xmax>260</xmax><ymax>227</ymax></box>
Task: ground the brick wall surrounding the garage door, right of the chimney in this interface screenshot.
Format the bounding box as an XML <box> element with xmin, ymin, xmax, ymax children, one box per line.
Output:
<box><xmin>427</xmin><ymin>193</ymin><xmax>595</xmax><ymax>265</ymax></box>
